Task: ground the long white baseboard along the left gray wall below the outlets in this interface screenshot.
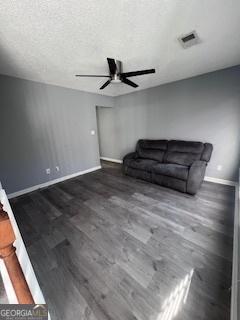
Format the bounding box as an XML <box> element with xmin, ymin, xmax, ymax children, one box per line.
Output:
<box><xmin>7</xmin><ymin>166</ymin><xmax>101</xmax><ymax>199</ymax></box>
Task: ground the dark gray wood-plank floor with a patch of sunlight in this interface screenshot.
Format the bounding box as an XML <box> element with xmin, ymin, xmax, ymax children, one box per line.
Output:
<box><xmin>11</xmin><ymin>163</ymin><xmax>234</xmax><ymax>320</ymax></box>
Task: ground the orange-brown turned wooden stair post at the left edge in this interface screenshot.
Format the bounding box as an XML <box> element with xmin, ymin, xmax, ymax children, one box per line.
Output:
<box><xmin>0</xmin><ymin>202</ymin><xmax>34</xmax><ymax>304</ymax></box>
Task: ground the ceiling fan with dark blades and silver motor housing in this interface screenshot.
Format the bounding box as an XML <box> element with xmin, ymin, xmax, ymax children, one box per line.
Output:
<box><xmin>76</xmin><ymin>58</ymin><xmax>155</xmax><ymax>90</ymax></box>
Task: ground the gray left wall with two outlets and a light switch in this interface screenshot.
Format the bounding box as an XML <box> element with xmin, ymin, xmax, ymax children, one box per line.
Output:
<box><xmin>0</xmin><ymin>76</ymin><xmax>113</xmax><ymax>193</ymax></box>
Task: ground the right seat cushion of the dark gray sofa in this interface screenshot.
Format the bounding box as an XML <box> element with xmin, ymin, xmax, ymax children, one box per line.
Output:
<box><xmin>152</xmin><ymin>163</ymin><xmax>189</xmax><ymax>180</ymax></box>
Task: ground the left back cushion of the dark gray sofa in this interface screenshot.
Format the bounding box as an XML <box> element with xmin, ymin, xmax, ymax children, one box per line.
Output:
<box><xmin>137</xmin><ymin>140</ymin><xmax>168</xmax><ymax>162</ymax></box>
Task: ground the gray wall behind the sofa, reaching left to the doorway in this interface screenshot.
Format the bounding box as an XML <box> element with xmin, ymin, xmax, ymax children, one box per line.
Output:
<box><xmin>98</xmin><ymin>67</ymin><xmax>240</xmax><ymax>180</ymax></box>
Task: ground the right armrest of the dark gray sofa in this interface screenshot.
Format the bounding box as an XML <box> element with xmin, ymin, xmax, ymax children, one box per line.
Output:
<box><xmin>187</xmin><ymin>160</ymin><xmax>207</xmax><ymax>194</ymax></box>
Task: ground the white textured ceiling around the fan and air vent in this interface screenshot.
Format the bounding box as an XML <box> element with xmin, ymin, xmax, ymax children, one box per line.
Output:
<box><xmin>0</xmin><ymin>0</ymin><xmax>240</xmax><ymax>96</ymax></box>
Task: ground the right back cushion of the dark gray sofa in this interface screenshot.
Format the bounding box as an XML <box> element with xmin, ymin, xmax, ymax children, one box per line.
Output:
<box><xmin>164</xmin><ymin>140</ymin><xmax>204</xmax><ymax>166</ymax></box>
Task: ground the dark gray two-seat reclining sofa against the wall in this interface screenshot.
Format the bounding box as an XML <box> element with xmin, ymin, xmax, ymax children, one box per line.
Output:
<box><xmin>123</xmin><ymin>140</ymin><xmax>213</xmax><ymax>194</ymax></box>
